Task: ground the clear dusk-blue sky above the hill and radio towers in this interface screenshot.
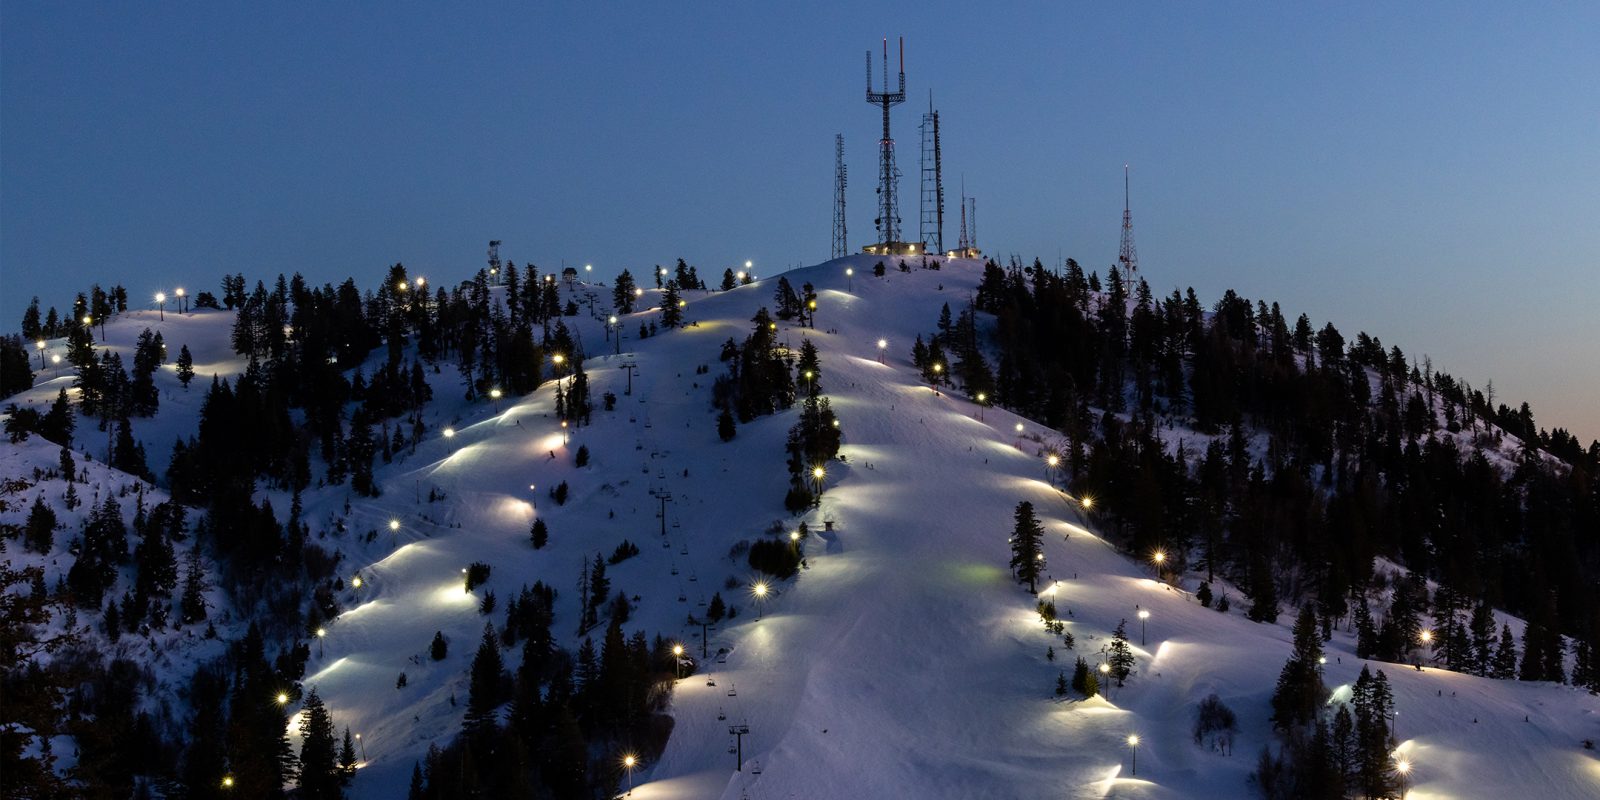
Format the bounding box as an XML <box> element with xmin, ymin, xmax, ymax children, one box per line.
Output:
<box><xmin>0</xmin><ymin>0</ymin><xmax>1600</xmax><ymax>442</ymax></box>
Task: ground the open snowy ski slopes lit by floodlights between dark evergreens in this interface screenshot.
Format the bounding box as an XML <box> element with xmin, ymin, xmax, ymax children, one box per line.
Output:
<box><xmin>5</xmin><ymin>256</ymin><xmax>1600</xmax><ymax>800</ymax></box>
